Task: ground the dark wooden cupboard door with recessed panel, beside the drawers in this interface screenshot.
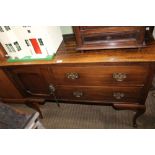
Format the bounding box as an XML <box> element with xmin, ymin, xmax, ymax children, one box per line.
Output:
<box><xmin>9</xmin><ymin>66</ymin><xmax>52</xmax><ymax>97</ymax></box>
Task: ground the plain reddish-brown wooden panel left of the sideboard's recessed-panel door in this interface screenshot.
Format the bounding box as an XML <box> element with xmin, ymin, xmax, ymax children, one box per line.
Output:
<box><xmin>0</xmin><ymin>69</ymin><xmax>22</xmax><ymax>99</ymax></box>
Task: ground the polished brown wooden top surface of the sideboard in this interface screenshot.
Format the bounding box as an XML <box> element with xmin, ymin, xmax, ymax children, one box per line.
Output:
<box><xmin>0</xmin><ymin>36</ymin><xmax>155</xmax><ymax>66</ymax></box>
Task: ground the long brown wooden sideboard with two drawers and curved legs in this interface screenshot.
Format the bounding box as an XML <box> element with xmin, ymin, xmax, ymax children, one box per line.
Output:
<box><xmin>0</xmin><ymin>36</ymin><xmax>155</xmax><ymax>127</ymax></box>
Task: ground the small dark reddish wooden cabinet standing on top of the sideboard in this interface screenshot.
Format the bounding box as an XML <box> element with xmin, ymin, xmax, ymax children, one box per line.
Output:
<box><xmin>73</xmin><ymin>26</ymin><xmax>145</xmax><ymax>50</ymax></box>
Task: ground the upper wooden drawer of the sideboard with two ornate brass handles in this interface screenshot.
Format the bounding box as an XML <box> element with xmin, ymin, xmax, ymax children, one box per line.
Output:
<box><xmin>53</xmin><ymin>65</ymin><xmax>149</xmax><ymax>86</ymax></box>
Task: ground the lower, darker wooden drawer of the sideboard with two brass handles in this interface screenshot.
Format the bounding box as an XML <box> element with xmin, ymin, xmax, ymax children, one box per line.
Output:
<box><xmin>57</xmin><ymin>86</ymin><xmax>143</xmax><ymax>102</ymax></box>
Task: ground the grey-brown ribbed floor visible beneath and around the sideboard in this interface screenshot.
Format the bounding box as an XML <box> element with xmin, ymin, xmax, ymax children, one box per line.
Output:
<box><xmin>9</xmin><ymin>91</ymin><xmax>155</xmax><ymax>129</ymax></box>
